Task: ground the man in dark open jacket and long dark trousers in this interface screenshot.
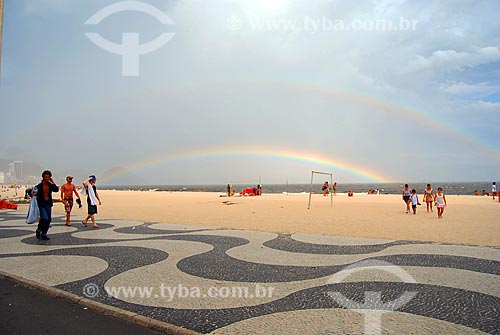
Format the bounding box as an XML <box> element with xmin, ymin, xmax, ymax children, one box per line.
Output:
<box><xmin>33</xmin><ymin>170</ymin><xmax>59</xmax><ymax>241</ymax></box>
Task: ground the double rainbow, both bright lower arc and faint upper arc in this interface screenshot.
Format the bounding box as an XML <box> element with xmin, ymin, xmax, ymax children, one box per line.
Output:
<box><xmin>99</xmin><ymin>81</ymin><xmax>500</xmax><ymax>182</ymax></box>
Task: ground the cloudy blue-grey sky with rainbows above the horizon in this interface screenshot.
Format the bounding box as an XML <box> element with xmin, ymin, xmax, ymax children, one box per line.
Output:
<box><xmin>0</xmin><ymin>0</ymin><xmax>500</xmax><ymax>184</ymax></box>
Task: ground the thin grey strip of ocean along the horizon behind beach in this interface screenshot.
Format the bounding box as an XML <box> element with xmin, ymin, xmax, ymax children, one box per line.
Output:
<box><xmin>99</xmin><ymin>182</ymin><xmax>491</xmax><ymax>195</ymax></box>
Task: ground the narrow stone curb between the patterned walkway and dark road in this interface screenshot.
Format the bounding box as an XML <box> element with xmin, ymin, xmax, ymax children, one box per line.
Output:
<box><xmin>0</xmin><ymin>271</ymin><xmax>201</xmax><ymax>335</ymax></box>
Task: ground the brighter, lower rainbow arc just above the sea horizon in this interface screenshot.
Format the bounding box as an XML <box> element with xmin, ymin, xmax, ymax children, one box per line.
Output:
<box><xmin>101</xmin><ymin>146</ymin><xmax>391</xmax><ymax>183</ymax></box>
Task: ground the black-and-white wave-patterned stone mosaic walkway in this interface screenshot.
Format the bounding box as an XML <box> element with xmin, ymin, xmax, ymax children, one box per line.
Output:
<box><xmin>0</xmin><ymin>211</ymin><xmax>500</xmax><ymax>334</ymax></box>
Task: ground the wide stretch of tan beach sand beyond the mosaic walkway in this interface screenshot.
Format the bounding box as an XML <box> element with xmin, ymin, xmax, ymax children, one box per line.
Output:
<box><xmin>42</xmin><ymin>190</ymin><xmax>500</xmax><ymax>246</ymax></box>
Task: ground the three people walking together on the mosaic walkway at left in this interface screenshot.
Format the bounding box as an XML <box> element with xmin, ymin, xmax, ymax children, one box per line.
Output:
<box><xmin>30</xmin><ymin>170</ymin><xmax>101</xmax><ymax>240</ymax></box>
